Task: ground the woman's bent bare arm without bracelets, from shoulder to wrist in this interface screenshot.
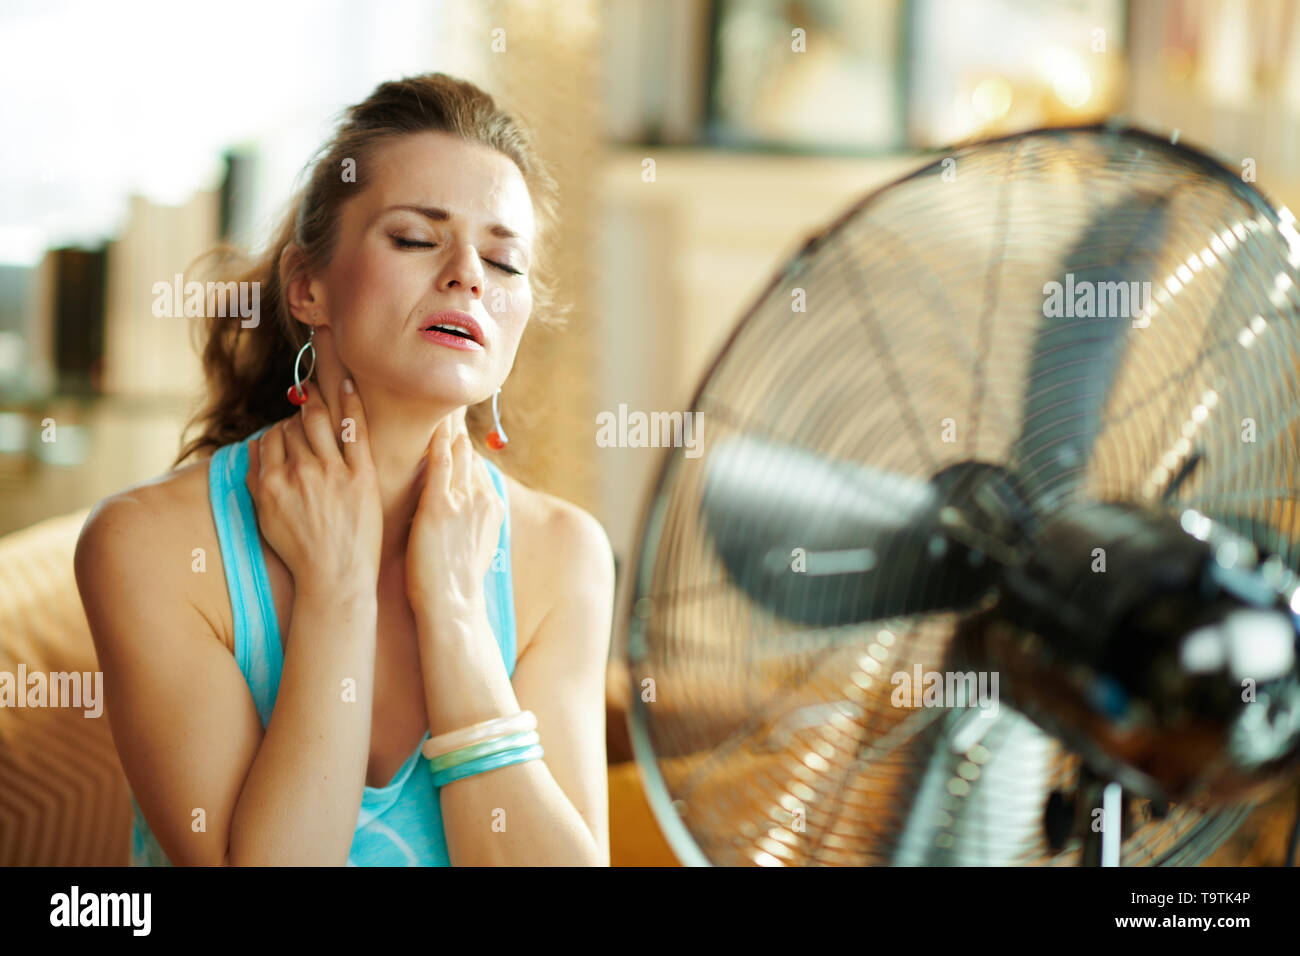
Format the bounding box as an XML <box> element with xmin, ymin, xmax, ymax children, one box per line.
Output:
<box><xmin>75</xmin><ymin>374</ymin><xmax>377</xmax><ymax>865</ymax></box>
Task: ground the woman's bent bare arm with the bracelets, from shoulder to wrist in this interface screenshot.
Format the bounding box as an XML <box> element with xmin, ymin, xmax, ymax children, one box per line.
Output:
<box><xmin>419</xmin><ymin>494</ymin><xmax>614</xmax><ymax>866</ymax></box>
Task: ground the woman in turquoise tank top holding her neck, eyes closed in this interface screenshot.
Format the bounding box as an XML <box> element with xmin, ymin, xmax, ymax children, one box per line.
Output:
<box><xmin>75</xmin><ymin>74</ymin><xmax>614</xmax><ymax>866</ymax></box>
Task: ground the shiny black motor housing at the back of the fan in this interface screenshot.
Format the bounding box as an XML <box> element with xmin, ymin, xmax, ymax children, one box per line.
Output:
<box><xmin>954</xmin><ymin>502</ymin><xmax>1300</xmax><ymax>801</ymax></box>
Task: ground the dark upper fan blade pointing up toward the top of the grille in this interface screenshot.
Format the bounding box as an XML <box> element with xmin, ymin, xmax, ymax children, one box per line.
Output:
<box><xmin>1013</xmin><ymin>193</ymin><xmax>1169</xmax><ymax>505</ymax></box>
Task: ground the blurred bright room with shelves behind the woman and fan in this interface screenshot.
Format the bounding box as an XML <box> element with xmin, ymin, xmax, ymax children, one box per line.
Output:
<box><xmin>0</xmin><ymin>0</ymin><xmax>1300</xmax><ymax>868</ymax></box>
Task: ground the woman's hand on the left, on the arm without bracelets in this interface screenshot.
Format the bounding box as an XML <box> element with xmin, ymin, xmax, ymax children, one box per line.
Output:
<box><xmin>246</xmin><ymin>378</ymin><xmax>384</xmax><ymax>594</ymax></box>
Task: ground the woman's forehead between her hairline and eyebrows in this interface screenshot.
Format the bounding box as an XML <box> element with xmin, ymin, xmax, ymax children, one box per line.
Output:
<box><xmin>358</xmin><ymin>133</ymin><xmax>536</xmax><ymax>242</ymax></box>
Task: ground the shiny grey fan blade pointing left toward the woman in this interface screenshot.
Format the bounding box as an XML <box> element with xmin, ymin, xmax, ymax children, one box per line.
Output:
<box><xmin>701</xmin><ymin>437</ymin><xmax>997</xmax><ymax>627</ymax></box>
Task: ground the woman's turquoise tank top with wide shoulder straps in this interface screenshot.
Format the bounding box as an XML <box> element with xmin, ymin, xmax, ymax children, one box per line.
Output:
<box><xmin>131</xmin><ymin>425</ymin><xmax>515</xmax><ymax>866</ymax></box>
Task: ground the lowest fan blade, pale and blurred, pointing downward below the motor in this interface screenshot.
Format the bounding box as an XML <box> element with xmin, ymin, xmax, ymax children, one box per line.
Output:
<box><xmin>892</xmin><ymin>702</ymin><xmax>1057</xmax><ymax>866</ymax></box>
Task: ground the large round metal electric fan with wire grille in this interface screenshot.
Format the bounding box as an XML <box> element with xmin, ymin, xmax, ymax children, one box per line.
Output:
<box><xmin>627</xmin><ymin>126</ymin><xmax>1300</xmax><ymax>865</ymax></box>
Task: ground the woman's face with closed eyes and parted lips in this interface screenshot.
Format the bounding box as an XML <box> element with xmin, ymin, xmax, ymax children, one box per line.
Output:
<box><xmin>311</xmin><ymin>133</ymin><xmax>534</xmax><ymax>406</ymax></box>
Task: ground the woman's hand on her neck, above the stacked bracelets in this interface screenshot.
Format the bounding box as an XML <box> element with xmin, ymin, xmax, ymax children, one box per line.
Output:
<box><xmin>406</xmin><ymin>408</ymin><xmax>506</xmax><ymax>618</ymax></box>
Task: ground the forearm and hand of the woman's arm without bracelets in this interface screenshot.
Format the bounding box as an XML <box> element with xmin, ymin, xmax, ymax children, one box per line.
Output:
<box><xmin>230</xmin><ymin>382</ymin><xmax>382</xmax><ymax>866</ymax></box>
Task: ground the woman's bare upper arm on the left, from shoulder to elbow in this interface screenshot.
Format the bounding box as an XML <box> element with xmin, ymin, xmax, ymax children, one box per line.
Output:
<box><xmin>74</xmin><ymin>494</ymin><xmax>261</xmax><ymax>865</ymax></box>
